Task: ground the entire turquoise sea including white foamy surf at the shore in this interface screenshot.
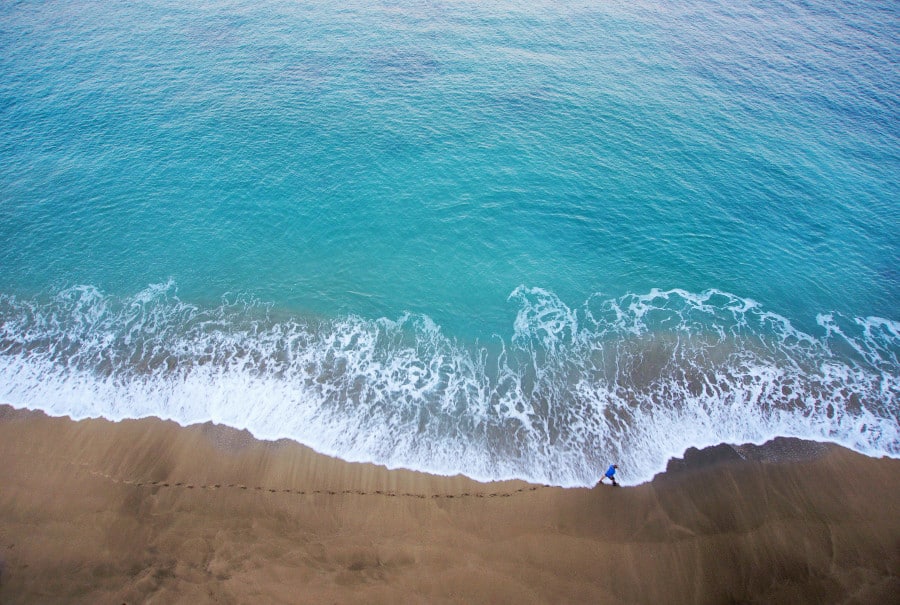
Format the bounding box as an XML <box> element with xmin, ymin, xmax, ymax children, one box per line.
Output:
<box><xmin>0</xmin><ymin>0</ymin><xmax>900</xmax><ymax>485</ymax></box>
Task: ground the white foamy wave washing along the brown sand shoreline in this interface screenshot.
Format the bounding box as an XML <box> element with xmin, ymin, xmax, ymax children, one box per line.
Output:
<box><xmin>0</xmin><ymin>282</ymin><xmax>900</xmax><ymax>486</ymax></box>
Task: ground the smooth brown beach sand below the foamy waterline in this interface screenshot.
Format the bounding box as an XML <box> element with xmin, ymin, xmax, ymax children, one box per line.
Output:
<box><xmin>0</xmin><ymin>406</ymin><xmax>900</xmax><ymax>604</ymax></box>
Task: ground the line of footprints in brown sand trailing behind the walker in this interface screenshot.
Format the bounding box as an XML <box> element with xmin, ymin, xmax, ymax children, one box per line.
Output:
<box><xmin>82</xmin><ymin>464</ymin><xmax>548</xmax><ymax>500</ymax></box>
